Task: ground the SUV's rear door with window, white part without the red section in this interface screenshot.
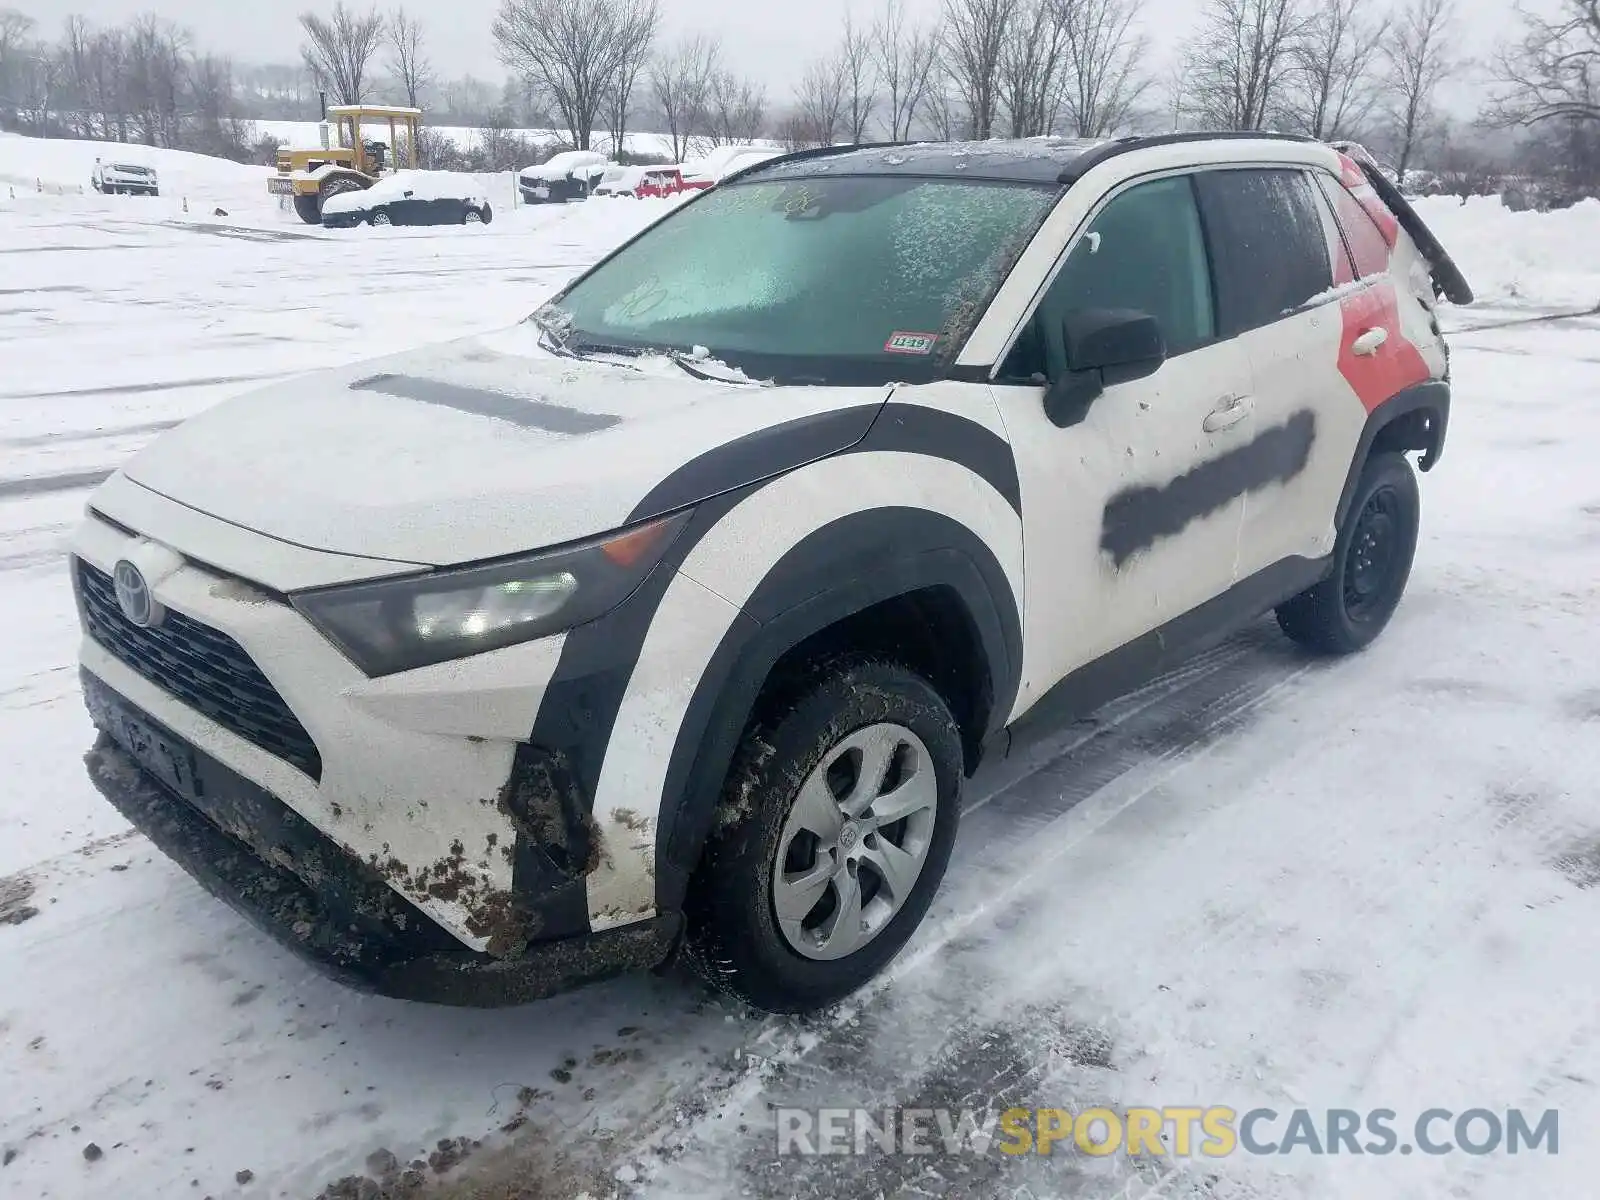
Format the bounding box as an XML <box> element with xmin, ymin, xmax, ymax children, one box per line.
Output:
<box><xmin>1195</xmin><ymin>166</ymin><xmax>1366</xmax><ymax>576</ymax></box>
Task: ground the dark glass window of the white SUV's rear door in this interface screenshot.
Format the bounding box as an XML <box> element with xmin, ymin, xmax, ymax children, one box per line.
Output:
<box><xmin>1195</xmin><ymin>170</ymin><xmax>1333</xmax><ymax>334</ymax></box>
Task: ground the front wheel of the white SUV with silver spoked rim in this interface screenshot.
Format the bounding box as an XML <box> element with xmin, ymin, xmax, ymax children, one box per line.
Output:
<box><xmin>685</xmin><ymin>659</ymin><xmax>962</xmax><ymax>1013</ymax></box>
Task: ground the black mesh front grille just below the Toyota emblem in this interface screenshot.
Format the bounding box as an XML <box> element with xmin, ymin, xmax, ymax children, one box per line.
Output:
<box><xmin>77</xmin><ymin>558</ymin><xmax>322</xmax><ymax>779</ymax></box>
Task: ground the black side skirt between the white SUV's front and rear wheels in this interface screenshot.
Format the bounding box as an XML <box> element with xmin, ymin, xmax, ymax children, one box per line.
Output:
<box><xmin>984</xmin><ymin>555</ymin><xmax>1333</xmax><ymax>758</ymax></box>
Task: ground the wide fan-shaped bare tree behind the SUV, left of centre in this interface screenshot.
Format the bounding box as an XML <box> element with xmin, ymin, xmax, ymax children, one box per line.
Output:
<box><xmin>494</xmin><ymin>0</ymin><xmax>659</xmax><ymax>150</ymax></box>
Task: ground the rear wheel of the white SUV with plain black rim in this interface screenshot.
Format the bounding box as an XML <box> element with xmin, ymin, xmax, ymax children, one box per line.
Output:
<box><xmin>1277</xmin><ymin>453</ymin><xmax>1422</xmax><ymax>654</ymax></box>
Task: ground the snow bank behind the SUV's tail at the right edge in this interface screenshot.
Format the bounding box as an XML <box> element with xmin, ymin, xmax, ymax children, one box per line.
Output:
<box><xmin>1411</xmin><ymin>197</ymin><xmax>1600</xmax><ymax>307</ymax></box>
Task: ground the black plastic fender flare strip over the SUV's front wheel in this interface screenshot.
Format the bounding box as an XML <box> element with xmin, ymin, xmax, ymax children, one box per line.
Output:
<box><xmin>656</xmin><ymin>507</ymin><xmax>1022</xmax><ymax>912</ymax></box>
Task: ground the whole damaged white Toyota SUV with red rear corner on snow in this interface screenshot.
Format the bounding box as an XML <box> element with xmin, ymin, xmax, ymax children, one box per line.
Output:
<box><xmin>72</xmin><ymin>136</ymin><xmax>1472</xmax><ymax>1011</ymax></box>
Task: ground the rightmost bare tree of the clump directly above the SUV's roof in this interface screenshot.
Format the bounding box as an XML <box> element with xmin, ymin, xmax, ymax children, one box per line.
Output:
<box><xmin>1062</xmin><ymin>0</ymin><xmax>1150</xmax><ymax>138</ymax></box>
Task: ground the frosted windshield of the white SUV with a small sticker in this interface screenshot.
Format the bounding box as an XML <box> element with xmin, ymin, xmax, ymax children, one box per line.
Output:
<box><xmin>536</xmin><ymin>176</ymin><xmax>1056</xmax><ymax>384</ymax></box>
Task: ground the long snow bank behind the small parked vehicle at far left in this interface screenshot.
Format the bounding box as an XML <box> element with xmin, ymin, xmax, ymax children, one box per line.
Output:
<box><xmin>0</xmin><ymin>133</ymin><xmax>269</xmax><ymax>203</ymax></box>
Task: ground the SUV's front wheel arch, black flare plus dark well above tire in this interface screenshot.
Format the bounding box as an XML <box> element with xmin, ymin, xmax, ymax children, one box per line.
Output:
<box><xmin>656</xmin><ymin>507</ymin><xmax>1022</xmax><ymax>910</ymax></box>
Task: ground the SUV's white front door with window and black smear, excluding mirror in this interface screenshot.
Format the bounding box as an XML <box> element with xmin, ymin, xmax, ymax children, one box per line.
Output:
<box><xmin>994</xmin><ymin>174</ymin><xmax>1254</xmax><ymax>707</ymax></box>
